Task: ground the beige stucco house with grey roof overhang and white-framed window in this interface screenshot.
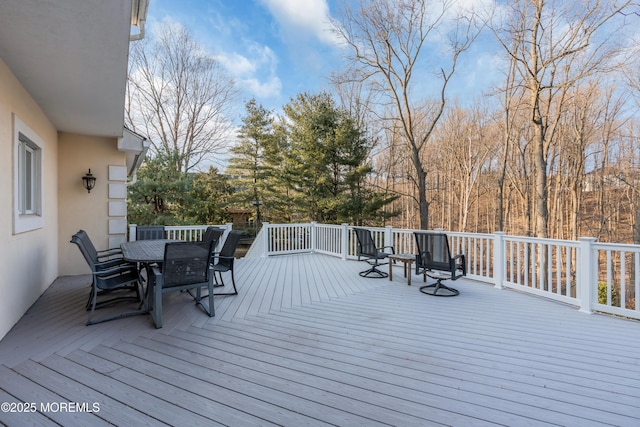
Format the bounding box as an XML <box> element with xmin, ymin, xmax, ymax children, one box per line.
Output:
<box><xmin>0</xmin><ymin>0</ymin><xmax>148</xmax><ymax>338</ymax></box>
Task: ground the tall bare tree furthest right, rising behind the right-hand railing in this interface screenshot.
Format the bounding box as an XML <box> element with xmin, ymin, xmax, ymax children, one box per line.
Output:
<box><xmin>493</xmin><ymin>0</ymin><xmax>631</xmax><ymax>237</ymax></box>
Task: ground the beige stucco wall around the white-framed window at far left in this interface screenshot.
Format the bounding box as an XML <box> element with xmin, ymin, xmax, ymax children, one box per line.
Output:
<box><xmin>0</xmin><ymin>59</ymin><xmax>58</xmax><ymax>338</ymax></box>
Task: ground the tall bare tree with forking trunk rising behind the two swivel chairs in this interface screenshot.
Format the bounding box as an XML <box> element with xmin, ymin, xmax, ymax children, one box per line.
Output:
<box><xmin>334</xmin><ymin>0</ymin><xmax>478</xmax><ymax>229</ymax></box>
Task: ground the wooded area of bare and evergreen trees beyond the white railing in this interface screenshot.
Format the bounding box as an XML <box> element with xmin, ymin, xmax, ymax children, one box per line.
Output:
<box><xmin>128</xmin><ymin>0</ymin><xmax>640</xmax><ymax>243</ymax></box>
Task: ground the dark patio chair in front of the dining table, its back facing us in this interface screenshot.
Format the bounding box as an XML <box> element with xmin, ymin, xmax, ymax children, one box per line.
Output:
<box><xmin>148</xmin><ymin>241</ymin><xmax>215</xmax><ymax>328</ymax></box>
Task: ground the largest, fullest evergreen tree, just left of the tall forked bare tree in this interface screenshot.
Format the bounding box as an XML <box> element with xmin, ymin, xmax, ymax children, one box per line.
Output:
<box><xmin>282</xmin><ymin>93</ymin><xmax>394</xmax><ymax>224</ymax></box>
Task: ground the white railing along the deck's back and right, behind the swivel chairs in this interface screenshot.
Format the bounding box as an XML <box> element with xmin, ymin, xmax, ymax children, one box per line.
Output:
<box><xmin>247</xmin><ymin>222</ymin><xmax>640</xmax><ymax>319</ymax></box>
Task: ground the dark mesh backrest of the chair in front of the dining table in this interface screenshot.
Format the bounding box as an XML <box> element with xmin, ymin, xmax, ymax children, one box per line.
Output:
<box><xmin>162</xmin><ymin>241</ymin><xmax>213</xmax><ymax>288</ymax></box>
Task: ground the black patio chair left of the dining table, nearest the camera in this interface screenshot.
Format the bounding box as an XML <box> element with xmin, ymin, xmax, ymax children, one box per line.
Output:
<box><xmin>71</xmin><ymin>232</ymin><xmax>146</xmax><ymax>325</ymax></box>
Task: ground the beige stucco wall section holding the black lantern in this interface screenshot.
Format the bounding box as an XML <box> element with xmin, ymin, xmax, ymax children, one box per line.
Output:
<box><xmin>58</xmin><ymin>133</ymin><xmax>125</xmax><ymax>276</ymax></box>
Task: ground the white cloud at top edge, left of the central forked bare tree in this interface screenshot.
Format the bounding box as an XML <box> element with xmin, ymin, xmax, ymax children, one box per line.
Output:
<box><xmin>261</xmin><ymin>0</ymin><xmax>338</xmax><ymax>45</ymax></box>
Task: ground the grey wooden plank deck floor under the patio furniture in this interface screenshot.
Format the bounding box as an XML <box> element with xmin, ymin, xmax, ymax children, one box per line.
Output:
<box><xmin>0</xmin><ymin>254</ymin><xmax>640</xmax><ymax>427</ymax></box>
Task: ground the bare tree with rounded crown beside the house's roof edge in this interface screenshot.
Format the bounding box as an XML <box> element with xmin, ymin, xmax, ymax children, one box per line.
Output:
<box><xmin>126</xmin><ymin>24</ymin><xmax>236</xmax><ymax>172</ymax></box>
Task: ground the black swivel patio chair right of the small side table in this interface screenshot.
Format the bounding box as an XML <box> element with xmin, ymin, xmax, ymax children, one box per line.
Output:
<box><xmin>413</xmin><ymin>231</ymin><xmax>467</xmax><ymax>297</ymax></box>
